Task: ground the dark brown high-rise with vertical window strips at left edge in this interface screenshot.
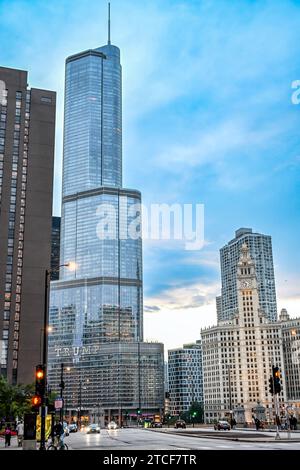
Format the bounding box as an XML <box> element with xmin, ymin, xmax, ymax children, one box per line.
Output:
<box><xmin>0</xmin><ymin>67</ymin><xmax>56</xmax><ymax>383</ymax></box>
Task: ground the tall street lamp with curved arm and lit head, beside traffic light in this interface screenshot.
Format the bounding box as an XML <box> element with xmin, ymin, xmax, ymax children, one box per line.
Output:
<box><xmin>40</xmin><ymin>262</ymin><xmax>75</xmax><ymax>450</ymax></box>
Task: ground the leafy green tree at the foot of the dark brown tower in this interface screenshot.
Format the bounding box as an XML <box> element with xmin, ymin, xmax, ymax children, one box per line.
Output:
<box><xmin>0</xmin><ymin>377</ymin><xmax>34</xmax><ymax>421</ymax></box>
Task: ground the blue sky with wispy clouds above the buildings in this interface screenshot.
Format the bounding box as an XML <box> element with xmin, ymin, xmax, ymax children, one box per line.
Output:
<box><xmin>0</xmin><ymin>0</ymin><xmax>300</xmax><ymax>348</ymax></box>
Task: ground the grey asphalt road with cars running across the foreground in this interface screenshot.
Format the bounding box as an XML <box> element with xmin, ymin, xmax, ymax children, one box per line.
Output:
<box><xmin>61</xmin><ymin>429</ymin><xmax>300</xmax><ymax>450</ymax></box>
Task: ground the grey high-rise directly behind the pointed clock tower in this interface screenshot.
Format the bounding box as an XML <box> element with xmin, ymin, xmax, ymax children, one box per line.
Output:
<box><xmin>218</xmin><ymin>228</ymin><xmax>277</xmax><ymax>321</ymax></box>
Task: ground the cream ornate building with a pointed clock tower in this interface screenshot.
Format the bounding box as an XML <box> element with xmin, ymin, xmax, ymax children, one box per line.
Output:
<box><xmin>201</xmin><ymin>243</ymin><xmax>286</xmax><ymax>423</ymax></box>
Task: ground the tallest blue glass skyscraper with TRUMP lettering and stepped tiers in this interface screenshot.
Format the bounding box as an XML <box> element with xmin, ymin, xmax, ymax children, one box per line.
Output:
<box><xmin>48</xmin><ymin>9</ymin><xmax>163</xmax><ymax>418</ymax></box>
